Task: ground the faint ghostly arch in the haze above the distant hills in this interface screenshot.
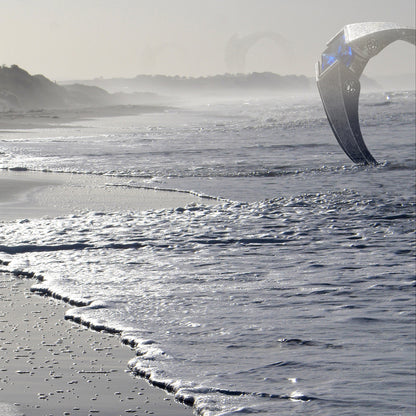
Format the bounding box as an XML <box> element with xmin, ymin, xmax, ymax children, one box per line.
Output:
<box><xmin>225</xmin><ymin>32</ymin><xmax>293</xmax><ymax>73</ymax></box>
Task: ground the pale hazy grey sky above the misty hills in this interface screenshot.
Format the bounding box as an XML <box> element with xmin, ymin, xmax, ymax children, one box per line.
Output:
<box><xmin>0</xmin><ymin>0</ymin><xmax>415</xmax><ymax>80</ymax></box>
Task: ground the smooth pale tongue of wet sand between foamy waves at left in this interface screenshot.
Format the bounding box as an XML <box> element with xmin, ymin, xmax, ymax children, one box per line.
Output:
<box><xmin>0</xmin><ymin>170</ymin><xmax>206</xmax><ymax>221</ymax></box>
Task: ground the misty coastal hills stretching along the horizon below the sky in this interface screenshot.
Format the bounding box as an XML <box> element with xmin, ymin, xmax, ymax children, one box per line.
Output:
<box><xmin>0</xmin><ymin>65</ymin><xmax>311</xmax><ymax>111</ymax></box>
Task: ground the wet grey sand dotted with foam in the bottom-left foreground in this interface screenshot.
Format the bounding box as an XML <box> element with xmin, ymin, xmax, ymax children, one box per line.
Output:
<box><xmin>0</xmin><ymin>273</ymin><xmax>192</xmax><ymax>416</ymax></box>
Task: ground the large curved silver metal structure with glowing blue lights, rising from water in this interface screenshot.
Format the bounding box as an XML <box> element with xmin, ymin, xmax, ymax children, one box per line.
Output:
<box><xmin>316</xmin><ymin>22</ymin><xmax>416</xmax><ymax>164</ymax></box>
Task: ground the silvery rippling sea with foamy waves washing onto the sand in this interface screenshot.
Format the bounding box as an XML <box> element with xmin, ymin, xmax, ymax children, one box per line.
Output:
<box><xmin>0</xmin><ymin>91</ymin><xmax>416</xmax><ymax>416</ymax></box>
